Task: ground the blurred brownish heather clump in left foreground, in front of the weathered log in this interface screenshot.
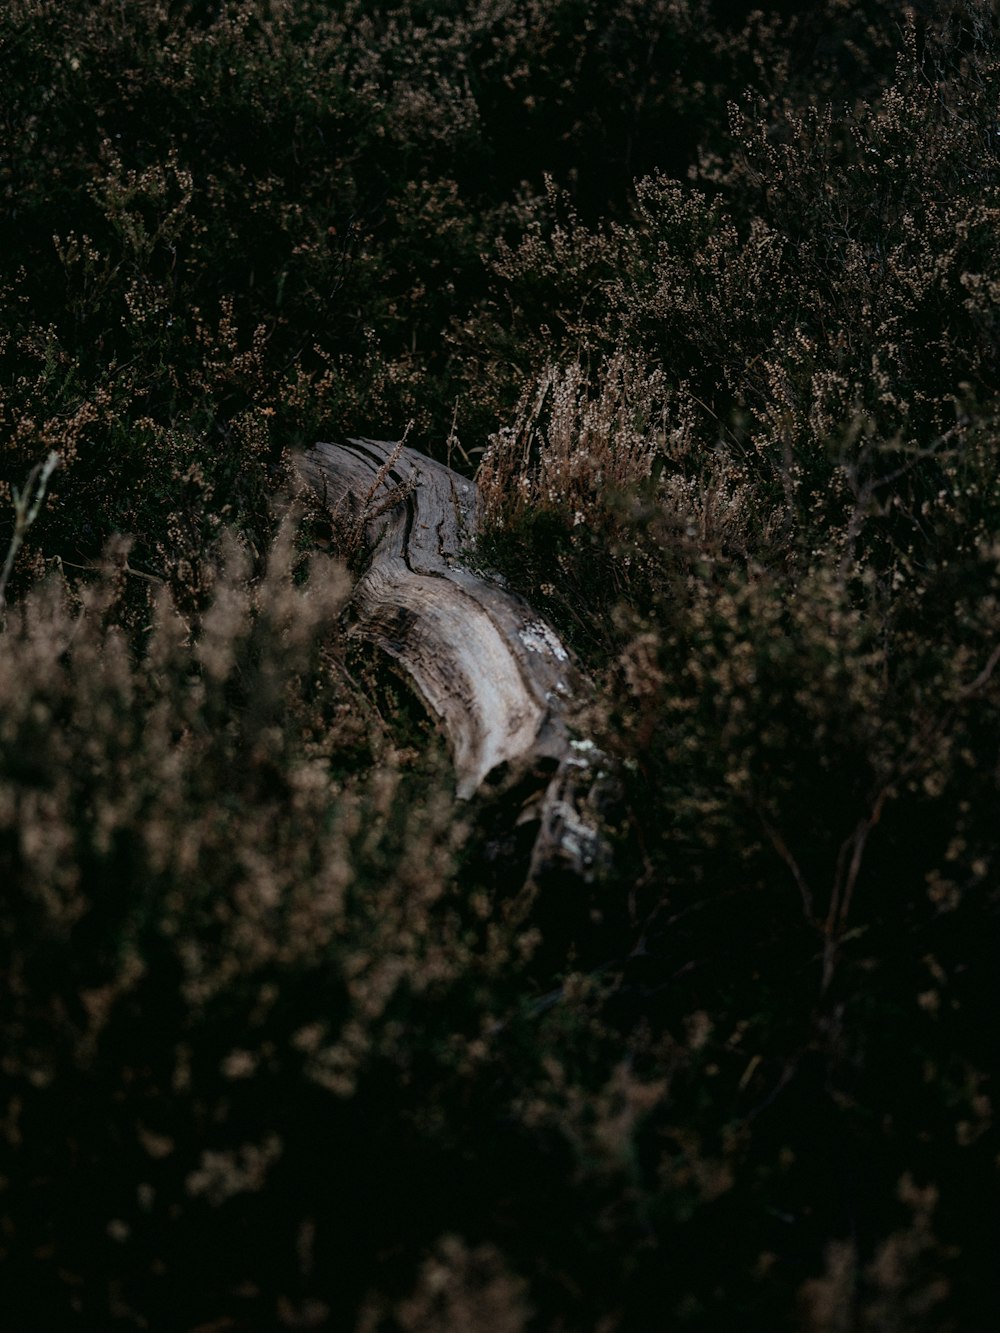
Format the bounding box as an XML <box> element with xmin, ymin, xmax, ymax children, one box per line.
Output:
<box><xmin>0</xmin><ymin>528</ymin><xmax>541</xmax><ymax>1329</ymax></box>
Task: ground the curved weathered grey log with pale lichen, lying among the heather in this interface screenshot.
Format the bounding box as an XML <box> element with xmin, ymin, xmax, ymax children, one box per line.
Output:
<box><xmin>300</xmin><ymin>439</ymin><xmax>603</xmax><ymax>874</ymax></box>
